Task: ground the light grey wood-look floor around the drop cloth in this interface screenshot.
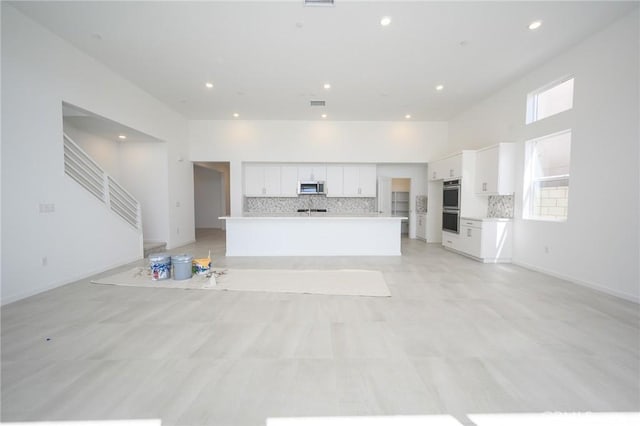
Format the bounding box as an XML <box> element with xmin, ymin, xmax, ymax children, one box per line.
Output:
<box><xmin>1</xmin><ymin>230</ymin><xmax>640</xmax><ymax>426</ymax></box>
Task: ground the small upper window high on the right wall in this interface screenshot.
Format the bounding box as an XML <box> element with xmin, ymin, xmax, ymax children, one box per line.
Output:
<box><xmin>527</xmin><ymin>78</ymin><xmax>573</xmax><ymax>124</ymax></box>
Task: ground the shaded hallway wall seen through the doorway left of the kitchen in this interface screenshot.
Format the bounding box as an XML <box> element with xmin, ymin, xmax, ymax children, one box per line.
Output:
<box><xmin>193</xmin><ymin>166</ymin><xmax>225</xmax><ymax>229</ymax></box>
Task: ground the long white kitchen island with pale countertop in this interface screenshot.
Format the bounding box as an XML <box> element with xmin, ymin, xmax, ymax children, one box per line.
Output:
<box><xmin>220</xmin><ymin>214</ymin><xmax>406</xmax><ymax>256</ymax></box>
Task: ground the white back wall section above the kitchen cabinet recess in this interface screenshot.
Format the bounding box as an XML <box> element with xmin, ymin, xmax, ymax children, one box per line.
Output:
<box><xmin>189</xmin><ymin>120</ymin><xmax>450</xmax><ymax>215</ymax></box>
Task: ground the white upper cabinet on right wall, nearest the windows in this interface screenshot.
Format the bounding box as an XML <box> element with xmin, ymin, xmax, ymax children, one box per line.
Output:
<box><xmin>475</xmin><ymin>143</ymin><xmax>515</xmax><ymax>195</ymax></box>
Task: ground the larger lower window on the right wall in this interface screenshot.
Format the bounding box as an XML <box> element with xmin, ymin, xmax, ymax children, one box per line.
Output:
<box><xmin>524</xmin><ymin>130</ymin><xmax>571</xmax><ymax>221</ymax></box>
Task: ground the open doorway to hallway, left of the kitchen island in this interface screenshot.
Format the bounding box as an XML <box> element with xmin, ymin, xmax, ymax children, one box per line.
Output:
<box><xmin>193</xmin><ymin>162</ymin><xmax>230</xmax><ymax>235</ymax></box>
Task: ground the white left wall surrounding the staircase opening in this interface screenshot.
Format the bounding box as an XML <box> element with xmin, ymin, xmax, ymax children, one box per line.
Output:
<box><xmin>1</xmin><ymin>6</ymin><xmax>194</xmax><ymax>303</ymax></box>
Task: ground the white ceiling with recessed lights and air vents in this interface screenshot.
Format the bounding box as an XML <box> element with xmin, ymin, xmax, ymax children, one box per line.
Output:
<box><xmin>12</xmin><ymin>0</ymin><xmax>638</xmax><ymax>121</ymax></box>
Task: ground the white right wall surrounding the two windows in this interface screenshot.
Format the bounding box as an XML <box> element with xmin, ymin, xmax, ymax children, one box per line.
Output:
<box><xmin>449</xmin><ymin>10</ymin><xmax>640</xmax><ymax>300</ymax></box>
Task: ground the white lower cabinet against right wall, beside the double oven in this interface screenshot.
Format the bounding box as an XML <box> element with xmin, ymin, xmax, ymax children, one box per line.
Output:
<box><xmin>442</xmin><ymin>218</ymin><xmax>512</xmax><ymax>263</ymax></box>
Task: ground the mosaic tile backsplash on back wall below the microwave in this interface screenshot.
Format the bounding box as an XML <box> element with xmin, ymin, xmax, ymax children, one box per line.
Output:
<box><xmin>244</xmin><ymin>195</ymin><xmax>376</xmax><ymax>214</ymax></box>
